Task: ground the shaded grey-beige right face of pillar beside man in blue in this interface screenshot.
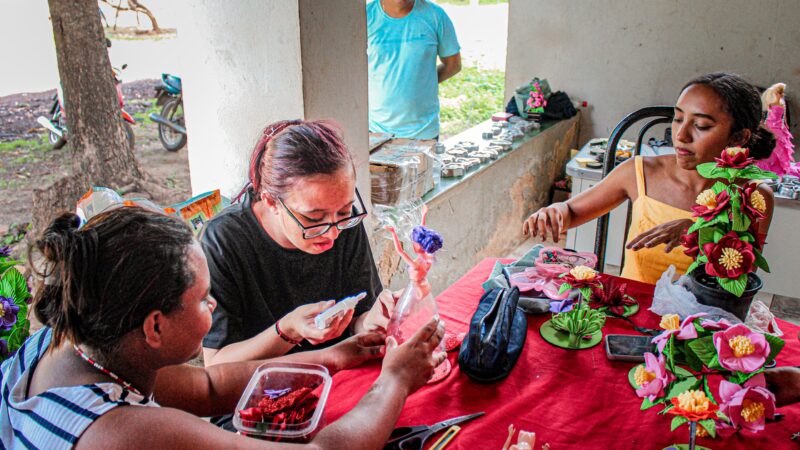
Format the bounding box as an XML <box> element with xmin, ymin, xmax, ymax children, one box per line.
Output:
<box><xmin>300</xmin><ymin>0</ymin><xmax>370</xmax><ymax>202</ymax></box>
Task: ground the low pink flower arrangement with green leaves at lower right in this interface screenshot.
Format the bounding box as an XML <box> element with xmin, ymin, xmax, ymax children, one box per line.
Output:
<box><xmin>628</xmin><ymin>313</ymin><xmax>784</xmax><ymax>448</ymax></box>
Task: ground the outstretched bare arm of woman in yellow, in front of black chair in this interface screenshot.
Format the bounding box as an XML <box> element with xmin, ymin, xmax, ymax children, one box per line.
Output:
<box><xmin>522</xmin><ymin>158</ymin><xmax>636</xmax><ymax>241</ymax></box>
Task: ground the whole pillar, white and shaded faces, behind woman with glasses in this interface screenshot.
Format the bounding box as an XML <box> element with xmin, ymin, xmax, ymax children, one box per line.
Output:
<box><xmin>178</xmin><ymin>0</ymin><xmax>369</xmax><ymax>199</ymax></box>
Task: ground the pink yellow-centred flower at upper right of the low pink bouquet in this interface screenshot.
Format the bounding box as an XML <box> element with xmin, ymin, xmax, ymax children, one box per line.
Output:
<box><xmin>714</xmin><ymin>323</ymin><xmax>770</xmax><ymax>373</ymax></box>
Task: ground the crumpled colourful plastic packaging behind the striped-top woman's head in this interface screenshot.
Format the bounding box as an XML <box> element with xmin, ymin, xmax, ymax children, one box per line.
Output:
<box><xmin>76</xmin><ymin>186</ymin><xmax>231</xmax><ymax>234</ymax></box>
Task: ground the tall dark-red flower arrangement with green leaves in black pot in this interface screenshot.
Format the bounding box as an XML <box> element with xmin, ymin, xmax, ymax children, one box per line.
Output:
<box><xmin>683</xmin><ymin>147</ymin><xmax>776</xmax><ymax>320</ymax></box>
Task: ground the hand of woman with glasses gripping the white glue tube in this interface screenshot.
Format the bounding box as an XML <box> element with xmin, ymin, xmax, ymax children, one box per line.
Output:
<box><xmin>279</xmin><ymin>300</ymin><xmax>355</xmax><ymax>345</ymax></box>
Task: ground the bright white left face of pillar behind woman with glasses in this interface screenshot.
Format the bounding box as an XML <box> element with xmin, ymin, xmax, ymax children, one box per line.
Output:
<box><xmin>178</xmin><ymin>0</ymin><xmax>303</xmax><ymax>196</ymax></box>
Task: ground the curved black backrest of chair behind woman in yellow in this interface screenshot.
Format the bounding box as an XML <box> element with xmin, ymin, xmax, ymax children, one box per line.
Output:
<box><xmin>594</xmin><ymin>106</ymin><xmax>675</xmax><ymax>272</ymax></box>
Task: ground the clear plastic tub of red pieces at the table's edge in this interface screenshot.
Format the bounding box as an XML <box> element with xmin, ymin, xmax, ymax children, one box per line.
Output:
<box><xmin>233</xmin><ymin>363</ymin><xmax>331</xmax><ymax>442</ymax></box>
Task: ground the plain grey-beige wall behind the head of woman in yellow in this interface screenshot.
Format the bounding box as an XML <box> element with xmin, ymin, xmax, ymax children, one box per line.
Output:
<box><xmin>506</xmin><ymin>0</ymin><xmax>800</xmax><ymax>148</ymax></box>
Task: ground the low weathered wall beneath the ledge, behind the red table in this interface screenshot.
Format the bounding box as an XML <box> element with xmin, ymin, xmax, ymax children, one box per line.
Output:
<box><xmin>373</xmin><ymin>116</ymin><xmax>580</xmax><ymax>294</ymax></box>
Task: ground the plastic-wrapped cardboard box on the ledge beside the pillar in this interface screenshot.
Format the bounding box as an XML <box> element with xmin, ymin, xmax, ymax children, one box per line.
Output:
<box><xmin>369</xmin><ymin>139</ymin><xmax>437</xmax><ymax>205</ymax></box>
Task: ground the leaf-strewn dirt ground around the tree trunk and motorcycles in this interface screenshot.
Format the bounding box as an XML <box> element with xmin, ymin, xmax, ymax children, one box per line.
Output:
<box><xmin>0</xmin><ymin>80</ymin><xmax>191</xmax><ymax>251</ymax></box>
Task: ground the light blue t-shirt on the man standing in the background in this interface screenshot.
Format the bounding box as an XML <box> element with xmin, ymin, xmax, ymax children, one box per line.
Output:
<box><xmin>367</xmin><ymin>0</ymin><xmax>460</xmax><ymax>139</ymax></box>
